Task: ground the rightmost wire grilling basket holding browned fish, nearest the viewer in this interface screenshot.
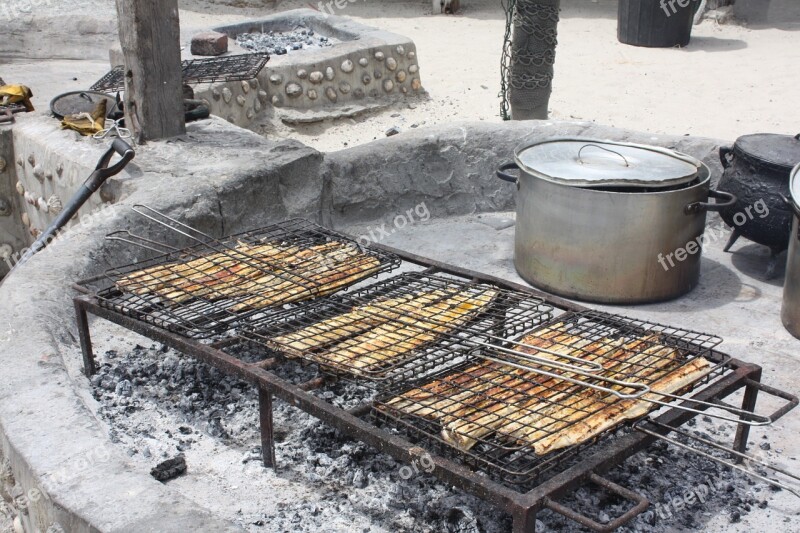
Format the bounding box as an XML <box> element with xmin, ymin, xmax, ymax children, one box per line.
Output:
<box><xmin>372</xmin><ymin>311</ymin><xmax>725</xmax><ymax>484</ymax></box>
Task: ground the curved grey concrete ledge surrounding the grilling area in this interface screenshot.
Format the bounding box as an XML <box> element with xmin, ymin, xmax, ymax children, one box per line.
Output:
<box><xmin>0</xmin><ymin>119</ymin><xmax>719</xmax><ymax>532</ymax></box>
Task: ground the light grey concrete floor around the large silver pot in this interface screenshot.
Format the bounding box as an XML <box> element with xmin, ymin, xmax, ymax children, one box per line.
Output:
<box><xmin>342</xmin><ymin>213</ymin><xmax>800</xmax><ymax>533</ymax></box>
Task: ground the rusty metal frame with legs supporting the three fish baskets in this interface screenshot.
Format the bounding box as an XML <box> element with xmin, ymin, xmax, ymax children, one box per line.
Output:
<box><xmin>74</xmin><ymin>242</ymin><xmax>799</xmax><ymax>533</ymax></box>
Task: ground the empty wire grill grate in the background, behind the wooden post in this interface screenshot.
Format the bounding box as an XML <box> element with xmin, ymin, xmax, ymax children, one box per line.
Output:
<box><xmin>91</xmin><ymin>54</ymin><xmax>269</xmax><ymax>92</ymax></box>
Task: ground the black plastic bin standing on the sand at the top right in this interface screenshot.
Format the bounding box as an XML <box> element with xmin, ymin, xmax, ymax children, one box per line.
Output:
<box><xmin>617</xmin><ymin>0</ymin><xmax>699</xmax><ymax>48</ymax></box>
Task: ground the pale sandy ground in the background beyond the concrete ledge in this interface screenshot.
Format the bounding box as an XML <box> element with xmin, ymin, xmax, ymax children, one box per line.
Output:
<box><xmin>0</xmin><ymin>0</ymin><xmax>800</xmax><ymax>151</ymax></box>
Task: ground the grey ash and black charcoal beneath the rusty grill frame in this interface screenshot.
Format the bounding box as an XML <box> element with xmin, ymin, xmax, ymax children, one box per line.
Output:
<box><xmin>92</xmin><ymin>345</ymin><xmax>771</xmax><ymax>533</ymax></box>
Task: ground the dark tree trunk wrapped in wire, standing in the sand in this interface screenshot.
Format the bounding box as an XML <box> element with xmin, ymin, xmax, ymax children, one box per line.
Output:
<box><xmin>508</xmin><ymin>0</ymin><xmax>561</xmax><ymax>120</ymax></box>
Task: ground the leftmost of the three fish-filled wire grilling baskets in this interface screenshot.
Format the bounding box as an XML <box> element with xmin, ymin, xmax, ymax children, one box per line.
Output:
<box><xmin>89</xmin><ymin>219</ymin><xmax>400</xmax><ymax>338</ymax></box>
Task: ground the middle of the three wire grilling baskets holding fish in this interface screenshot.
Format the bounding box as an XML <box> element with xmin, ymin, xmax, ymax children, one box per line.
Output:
<box><xmin>241</xmin><ymin>273</ymin><xmax>553</xmax><ymax>382</ymax></box>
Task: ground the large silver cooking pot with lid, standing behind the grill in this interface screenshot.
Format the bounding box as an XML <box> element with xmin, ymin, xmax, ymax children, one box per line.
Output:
<box><xmin>497</xmin><ymin>139</ymin><xmax>736</xmax><ymax>304</ymax></box>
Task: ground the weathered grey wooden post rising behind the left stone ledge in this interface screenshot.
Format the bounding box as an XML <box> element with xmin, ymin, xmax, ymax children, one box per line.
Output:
<box><xmin>117</xmin><ymin>0</ymin><xmax>186</xmax><ymax>143</ymax></box>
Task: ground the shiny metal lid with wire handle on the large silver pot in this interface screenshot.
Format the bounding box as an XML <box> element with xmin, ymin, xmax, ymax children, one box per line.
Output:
<box><xmin>517</xmin><ymin>138</ymin><xmax>701</xmax><ymax>188</ymax></box>
